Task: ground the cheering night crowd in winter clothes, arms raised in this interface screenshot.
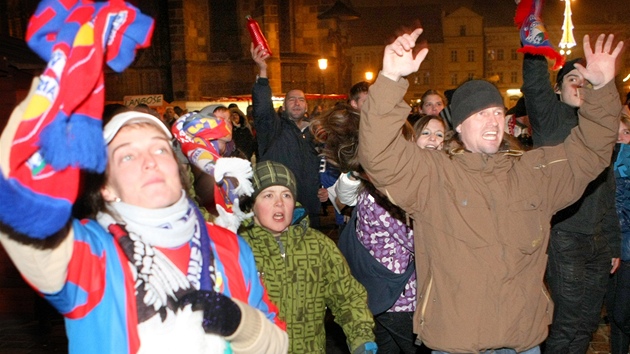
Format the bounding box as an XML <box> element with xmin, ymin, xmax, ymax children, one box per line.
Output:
<box><xmin>0</xmin><ymin>0</ymin><xmax>630</xmax><ymax>354</ymax></box>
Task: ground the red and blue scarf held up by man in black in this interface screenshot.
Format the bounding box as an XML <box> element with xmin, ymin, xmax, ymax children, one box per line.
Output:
<box><xmin>514</xmin><ymin>0</ymin><xmax>564</xmax><ymax>70</ymax></box>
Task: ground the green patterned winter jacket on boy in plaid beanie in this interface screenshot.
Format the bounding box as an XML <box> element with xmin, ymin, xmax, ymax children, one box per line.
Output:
<box><xmin>239</xmin><ymin>206</ymin><xmax>374</xmax><ymax>354</ymax></box>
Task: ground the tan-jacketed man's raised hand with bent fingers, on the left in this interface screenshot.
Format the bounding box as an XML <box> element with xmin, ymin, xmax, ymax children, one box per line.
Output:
<box><xmin>381</xmin><ymin>28</ymin><xmax>429</xmax><ymax>81</ymax></box>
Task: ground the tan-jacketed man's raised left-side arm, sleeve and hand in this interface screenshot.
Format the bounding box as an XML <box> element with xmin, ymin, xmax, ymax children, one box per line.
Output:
<box><xmin>358</xmin><ymin>29</ymin><xmax>430</xmax><ymax>212</ymax></box>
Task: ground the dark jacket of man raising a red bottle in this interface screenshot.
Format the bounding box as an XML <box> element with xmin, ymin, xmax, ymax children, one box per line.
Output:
<box><xmin>252</xmin><ymin>78</ymin><xmax>321</xmax><ymax>227</ymax></box>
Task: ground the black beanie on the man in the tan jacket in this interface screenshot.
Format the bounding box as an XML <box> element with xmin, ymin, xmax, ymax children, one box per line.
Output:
<box><xmin>451</xmin><ymin>80</ymin><xmax>505</xmax><ymax>128</ymax></box>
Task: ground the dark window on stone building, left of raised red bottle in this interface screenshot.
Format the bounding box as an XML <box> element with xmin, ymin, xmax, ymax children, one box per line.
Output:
<box><xmin>210</xmin><ymin>0</ymin><xmax>241</xmax><ymax>56</ymax></box>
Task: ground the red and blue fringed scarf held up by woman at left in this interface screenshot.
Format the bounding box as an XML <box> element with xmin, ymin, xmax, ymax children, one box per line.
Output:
<box><xmin>0</xmin><ymin>0</ymin><xmax>154</xmax><ymax>239</ymax></box>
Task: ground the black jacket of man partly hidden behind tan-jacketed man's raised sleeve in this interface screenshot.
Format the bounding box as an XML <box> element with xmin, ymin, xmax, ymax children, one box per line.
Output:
<box><xmin>521</xmin><ymin>55</ymin><xmax>621</xmax><ymax>257</ymax></box>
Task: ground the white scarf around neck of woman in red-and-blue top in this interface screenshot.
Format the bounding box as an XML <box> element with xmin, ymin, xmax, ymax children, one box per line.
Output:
<box><xmin>96</xmin><ymin>191</ymin><xmax>205</xmax><ymax>322</ymax></box>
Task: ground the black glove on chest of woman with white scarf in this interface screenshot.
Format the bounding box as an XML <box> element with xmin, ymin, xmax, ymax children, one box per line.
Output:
<box><xmin>180</xmin><ymin>290</ymin><xmax>241</xmax><ymax>337</ymax></box>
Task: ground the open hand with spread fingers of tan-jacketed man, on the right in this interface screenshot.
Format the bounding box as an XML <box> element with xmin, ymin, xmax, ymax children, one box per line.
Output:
<box><xmin>575</xmin><ymin>33</ymin><xmax>623</xmax><ymax>90</ymax></box>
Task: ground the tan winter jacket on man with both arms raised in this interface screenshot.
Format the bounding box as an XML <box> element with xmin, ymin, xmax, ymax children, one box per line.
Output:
<box><xmin>359</xmin><ymin>75</ymin><xmax>621</xmax><ymax>353</ymax></box>
